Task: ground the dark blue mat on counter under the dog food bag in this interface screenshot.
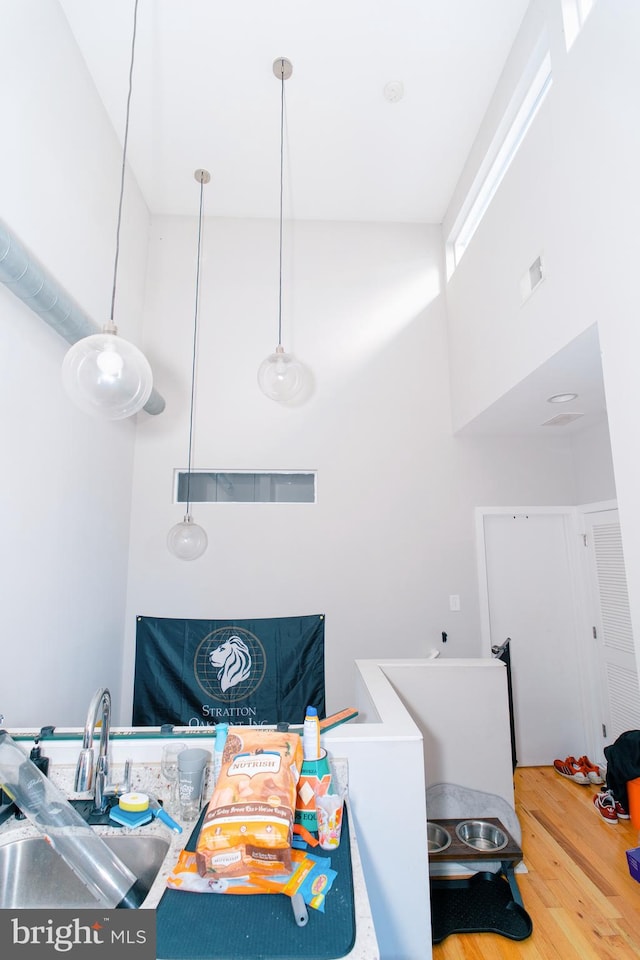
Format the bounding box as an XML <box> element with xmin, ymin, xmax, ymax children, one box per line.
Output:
<box><xmin>156</xmin><ymin>809</ymin><xmax>356</xmax><ymax>960</ymax></box>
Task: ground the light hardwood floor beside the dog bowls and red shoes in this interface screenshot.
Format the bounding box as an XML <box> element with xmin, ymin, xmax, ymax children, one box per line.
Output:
<box><xmin>433</xmin><ymin>767</ymin><xmax>640</xmax><ymax>960</ymax></box>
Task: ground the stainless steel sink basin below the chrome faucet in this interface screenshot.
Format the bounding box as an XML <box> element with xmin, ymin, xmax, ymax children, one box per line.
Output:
<box><xmin>0</xmin><ymin>835</ymin><xmax>169</xmax><ymax>910</ymax></box>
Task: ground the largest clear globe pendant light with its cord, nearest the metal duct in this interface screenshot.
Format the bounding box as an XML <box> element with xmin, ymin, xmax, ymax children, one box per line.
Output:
<box><xmin>62</xmin><ymin>0</ymin><xmax>153</xmax><ymax>420</ymax></box>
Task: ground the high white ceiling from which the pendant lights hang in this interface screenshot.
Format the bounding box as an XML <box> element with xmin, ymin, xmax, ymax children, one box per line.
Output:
<box><xmin>60</xmin><ymin>0</ymin><xmax>529</xmax><ymax>223</ymax></box>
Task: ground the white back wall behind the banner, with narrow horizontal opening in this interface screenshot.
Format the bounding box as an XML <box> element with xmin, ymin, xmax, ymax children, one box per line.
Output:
<box><xmin>122</xmin><ymin>212</ymin><xmax>575</xmax><ymax>723</ymax></box>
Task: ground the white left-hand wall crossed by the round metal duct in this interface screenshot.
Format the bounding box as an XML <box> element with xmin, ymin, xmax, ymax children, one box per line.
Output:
<box><xmin>0</xmin><ymin>0</ymin><xmax>147</xmax><ymax>726</ymax></box>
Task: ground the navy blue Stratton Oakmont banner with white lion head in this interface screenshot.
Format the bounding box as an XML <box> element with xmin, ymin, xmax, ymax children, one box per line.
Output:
<box><xmin>133</xmin><ymin>614</ymin><xmax>325</xmax><ymax>727</ymax></box>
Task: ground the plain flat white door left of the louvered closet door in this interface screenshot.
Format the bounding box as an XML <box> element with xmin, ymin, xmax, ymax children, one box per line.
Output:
<box><xmin>484</xmin><ymin>513</ymin><xmax>586</xmax><ymax>766</ymax></box>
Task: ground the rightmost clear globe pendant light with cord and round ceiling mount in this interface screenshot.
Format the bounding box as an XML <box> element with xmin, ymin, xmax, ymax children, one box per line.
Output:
<box><xmin>258</xmin><ymin>57</ymin><xmax>305</xmax><ymax>400</ymax></box>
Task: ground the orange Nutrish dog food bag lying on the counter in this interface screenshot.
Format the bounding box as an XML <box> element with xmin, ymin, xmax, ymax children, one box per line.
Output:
<box><xmin>196</xmin><ymin>727</ymin><xmax>303</xmax><ymax>878</ymax></box>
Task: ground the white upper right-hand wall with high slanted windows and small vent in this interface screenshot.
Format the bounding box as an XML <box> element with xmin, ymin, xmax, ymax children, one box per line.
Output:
<box><xmin>445</xmin><ymin>0</ymin><xmax>640</xmax><ymax>684</ymax></box>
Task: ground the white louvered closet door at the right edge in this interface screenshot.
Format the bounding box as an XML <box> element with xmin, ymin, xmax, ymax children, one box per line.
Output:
<box><xmin>586</xmin><ymin>510</ymin><xmax>640</xmax><ymax>745</ymax></box>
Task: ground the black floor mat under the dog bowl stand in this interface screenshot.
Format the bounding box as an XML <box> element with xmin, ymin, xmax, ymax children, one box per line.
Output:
<box><xmin>431</xmin><ymin>873</ymin><xmax>533</xmax><ymax>943</ymax></box>
